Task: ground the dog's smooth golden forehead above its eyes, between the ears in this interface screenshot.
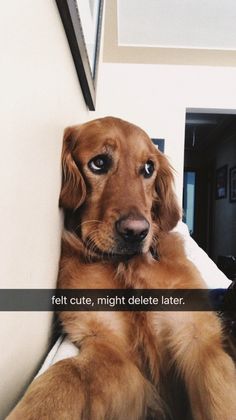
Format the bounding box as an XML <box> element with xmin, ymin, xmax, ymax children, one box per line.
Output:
<box><xmin>74</xmin><ymin>117</ymin><xmax>154</xmax><ymax>153</ymax></box>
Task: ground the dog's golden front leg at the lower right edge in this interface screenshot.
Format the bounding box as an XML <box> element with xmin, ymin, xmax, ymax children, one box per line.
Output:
<box><xmin>162</xmin><ymin>312</ymin><xmax>236</xmax><ymax>420</ymax></box>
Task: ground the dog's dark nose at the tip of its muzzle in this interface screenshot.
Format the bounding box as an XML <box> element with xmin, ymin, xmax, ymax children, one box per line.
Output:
<box><xmin>116</xmin><ymin>216</ymin><xmax>150</xmax><ymax>242</ymax></box>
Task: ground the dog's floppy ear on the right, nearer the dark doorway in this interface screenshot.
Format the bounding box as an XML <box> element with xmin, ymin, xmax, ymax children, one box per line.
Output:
<box><xmin>152</xmin><ymin>151</ymin><xmax>181</xmax><ymax>232</ymax></box>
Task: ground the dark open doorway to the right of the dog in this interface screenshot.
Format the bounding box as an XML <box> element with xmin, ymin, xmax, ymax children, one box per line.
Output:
<box><xmin>183</xmin><ymin>110</ymin><xmax>236</xmax><ymax>262</ymax></box>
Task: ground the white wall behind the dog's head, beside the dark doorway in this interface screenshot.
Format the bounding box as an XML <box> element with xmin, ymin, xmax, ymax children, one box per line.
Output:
<box><xmin>94</xmin><ymin>63</ymin><xmax>236</xmax><ymax>202</ymax></box>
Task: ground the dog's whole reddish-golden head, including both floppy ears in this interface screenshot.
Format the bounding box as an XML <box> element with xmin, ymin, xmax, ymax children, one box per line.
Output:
<box><xmin>60</xmin><ymin>117</ymin><xmax>180</xmax><ymax>257</ymax></box>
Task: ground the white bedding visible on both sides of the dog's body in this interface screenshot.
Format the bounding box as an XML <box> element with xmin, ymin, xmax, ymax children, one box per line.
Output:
<box><xmin>37</xmin><ymin>222</ymin><xmax>231</xmax><ymax>376</ymax></box>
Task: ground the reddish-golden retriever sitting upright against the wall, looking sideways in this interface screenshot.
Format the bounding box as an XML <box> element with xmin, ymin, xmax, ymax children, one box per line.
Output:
<box><xmin>9</xmin><ymin>117</ymin><xmax>236</xmax><ymax>420</ymax></box>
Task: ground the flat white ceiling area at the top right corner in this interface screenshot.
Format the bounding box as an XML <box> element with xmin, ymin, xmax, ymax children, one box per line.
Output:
<box><xmin>119</xmin><ymin>0</ymin><xmax>236</xmax><ymax>50</ymax></box>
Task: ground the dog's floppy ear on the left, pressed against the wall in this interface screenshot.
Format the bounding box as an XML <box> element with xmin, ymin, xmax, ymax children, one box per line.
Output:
<box><xmin>59</xmin><ymin>127</ymin><xmax>86</xmax><ymax>210</ymax></box>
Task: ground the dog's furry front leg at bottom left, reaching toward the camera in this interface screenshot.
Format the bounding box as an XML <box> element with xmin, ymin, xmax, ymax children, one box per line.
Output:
<box><xmin>7</xmin><ymin>336</ymin><xmax>160</xmax><ymax>420</ymax></box>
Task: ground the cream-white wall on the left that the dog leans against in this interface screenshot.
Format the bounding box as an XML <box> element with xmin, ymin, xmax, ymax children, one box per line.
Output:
<box><xmin>0</xmin><ymin>0</ymin><xmax>93</xmax><ymax>418</ymax></box>
